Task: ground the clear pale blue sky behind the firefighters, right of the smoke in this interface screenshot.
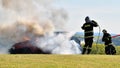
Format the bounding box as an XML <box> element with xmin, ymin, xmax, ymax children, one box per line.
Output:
<box><xmin>54</xmin><ymin>0</ymin><xmax>120</xmax><ymax>34</ymax></box>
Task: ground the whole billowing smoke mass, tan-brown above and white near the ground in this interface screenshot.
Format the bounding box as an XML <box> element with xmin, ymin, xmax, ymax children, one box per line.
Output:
<box><xmin>0</xmin><ymin>0</ymin><xmax>80</xmax><ymax>54</ymax></box>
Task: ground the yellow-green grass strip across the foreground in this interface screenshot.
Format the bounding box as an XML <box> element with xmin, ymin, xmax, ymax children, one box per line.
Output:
<box><xmin>0</xmin><ymin>54</ymin><xmax>120</xmax><ymax>68</ymax></box>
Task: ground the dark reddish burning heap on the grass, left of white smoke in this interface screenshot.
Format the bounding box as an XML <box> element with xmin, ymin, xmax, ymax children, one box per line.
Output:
<box><xmin>9</xmin><ymin>40</ymin><xmax>49</xmax><ymax>54</ymax></box>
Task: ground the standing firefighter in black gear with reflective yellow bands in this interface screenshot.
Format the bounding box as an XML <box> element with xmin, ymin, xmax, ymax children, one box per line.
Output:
<box><xmin>81</xmin><ymin>16</ymin><xmax>98</xmax><ymax>54</ymax></box>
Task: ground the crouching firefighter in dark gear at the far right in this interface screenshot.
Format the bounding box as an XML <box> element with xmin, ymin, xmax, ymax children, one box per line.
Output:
<box><xmin>102</xmin><ymin>29</ymin><xmax>116</xmax><ymax>55</ymax></box>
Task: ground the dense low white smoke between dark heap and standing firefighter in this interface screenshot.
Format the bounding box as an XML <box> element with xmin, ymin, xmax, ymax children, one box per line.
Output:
<box><xmin>36</xmin><ymin>34</ymin><xmax>81</xmax><ymax>54</ymax></box>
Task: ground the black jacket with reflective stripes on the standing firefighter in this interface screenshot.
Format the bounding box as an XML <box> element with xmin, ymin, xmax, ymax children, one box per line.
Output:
<box><xmin>81</xmin><ymin>20</ymin><xmax>98</xmax><ymax>38</ymax></box>
